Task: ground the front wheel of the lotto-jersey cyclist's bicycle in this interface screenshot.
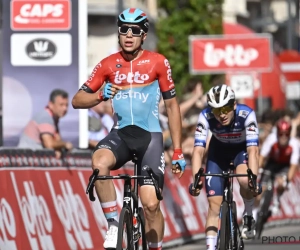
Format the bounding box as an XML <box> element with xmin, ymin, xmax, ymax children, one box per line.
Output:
<box><xmin>116</xmin><ymin>207</ymin><xmax>134</xmax><ymax>250</ymax></box>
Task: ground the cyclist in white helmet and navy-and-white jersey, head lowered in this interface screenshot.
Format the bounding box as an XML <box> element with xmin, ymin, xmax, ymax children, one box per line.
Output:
<box><xmin>189</xmin><ymin>85</ymin><xmax>259</xmax><ymax>250</ymax></box>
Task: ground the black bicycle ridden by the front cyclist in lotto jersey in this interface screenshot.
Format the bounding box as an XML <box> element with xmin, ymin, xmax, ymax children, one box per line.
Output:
<box><xmin>86</xmin><ymin>158</ymin><xmax>163</xmax><ymax>250</ymax></box>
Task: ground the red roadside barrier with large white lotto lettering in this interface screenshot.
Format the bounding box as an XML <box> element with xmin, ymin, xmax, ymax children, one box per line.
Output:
<box><xmin>0</xmin><ymin>167</ymin><xmax>300</xmax><ymax>250</ymax></box>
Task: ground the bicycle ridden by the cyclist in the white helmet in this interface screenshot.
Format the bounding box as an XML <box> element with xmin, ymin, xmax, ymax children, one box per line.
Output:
<box><xmin>193</xmin><ymin>163</ymin><xmax>256</xmax><ymax>250</ymax></box>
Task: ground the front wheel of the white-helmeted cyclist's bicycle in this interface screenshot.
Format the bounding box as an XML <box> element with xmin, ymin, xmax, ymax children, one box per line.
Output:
<box><xmin>219</xmin><ymin>202</ymin><xmax>231</xmax><ymax>250</ymax></box>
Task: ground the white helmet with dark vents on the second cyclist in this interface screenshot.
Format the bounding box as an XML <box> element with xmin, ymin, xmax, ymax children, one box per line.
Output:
<box><xmin>207</xmin><ymin>84</ymin><xmax>235</xmax><ymax>108</ymax></box>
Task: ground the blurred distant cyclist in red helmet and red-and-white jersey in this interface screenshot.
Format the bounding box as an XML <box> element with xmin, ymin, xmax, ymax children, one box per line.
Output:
<box><xmin>256</xmin><ymin>119</ymin><xmax>299</xmax><ymax>217</ymax></box>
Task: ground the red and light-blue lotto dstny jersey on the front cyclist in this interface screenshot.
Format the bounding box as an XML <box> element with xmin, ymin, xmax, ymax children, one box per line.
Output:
<box><xmin>81</xmin><ymin>50</ymin><xmax>176</xmax><ymax>132</ymax></box>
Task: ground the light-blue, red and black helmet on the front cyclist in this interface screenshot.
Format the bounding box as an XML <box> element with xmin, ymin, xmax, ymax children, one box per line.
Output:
<box><xmin>118</xmin><ymin>8</ymin><xmax>149</xmax><ymax>33</ymax></box>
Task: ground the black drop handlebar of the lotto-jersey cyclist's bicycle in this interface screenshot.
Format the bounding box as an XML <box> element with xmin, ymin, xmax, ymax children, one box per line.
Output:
<box><xmin>86</xmin><ymin>166</ymin><xmax>163</xmax><ymax>201</ymax></box>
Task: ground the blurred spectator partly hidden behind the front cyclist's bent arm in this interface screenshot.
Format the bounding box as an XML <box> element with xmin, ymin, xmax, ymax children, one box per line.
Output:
<box><xmin>89</xmin><ymin>101</ymin><xmax>114</xmax><ymax>149</ymax></box>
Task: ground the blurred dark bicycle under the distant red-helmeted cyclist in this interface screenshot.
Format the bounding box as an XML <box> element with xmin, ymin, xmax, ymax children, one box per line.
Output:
<box><xmin>255</xmin><ymin>170</ymin><xmax>274</xmax><ymax>239</ymax></box>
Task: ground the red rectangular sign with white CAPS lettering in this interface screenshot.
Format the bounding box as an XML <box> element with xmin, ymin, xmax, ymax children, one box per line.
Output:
<box><xmin>10</xmin><ymin>0</ymin><xmax>71</xmax><ymax>30</ymax></box>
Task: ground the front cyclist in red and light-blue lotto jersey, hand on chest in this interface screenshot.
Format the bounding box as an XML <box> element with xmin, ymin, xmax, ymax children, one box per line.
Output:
<box><xmin>72</xmin><ymin>8</ymin><xmax>186</xmax><ymax>250</ymax></box>
